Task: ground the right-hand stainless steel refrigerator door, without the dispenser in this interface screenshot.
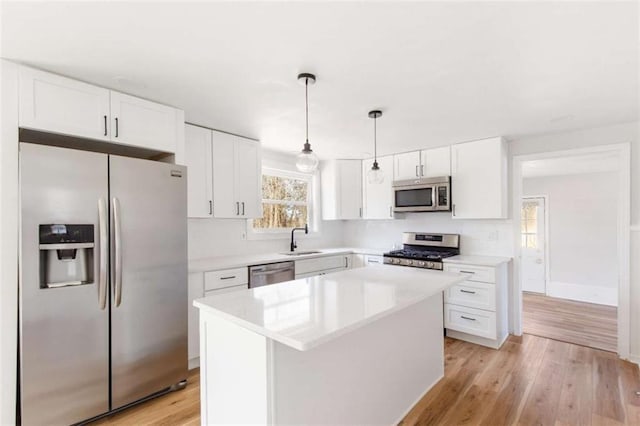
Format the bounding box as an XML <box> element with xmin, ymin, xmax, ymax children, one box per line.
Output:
<box><xmin>109</xmin><ymin>156</ymin><xmax>188</xmax><ymax>409</ymax></box>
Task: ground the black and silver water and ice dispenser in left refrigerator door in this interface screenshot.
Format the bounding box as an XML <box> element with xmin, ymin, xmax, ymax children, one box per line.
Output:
<box><xmin>39</xmin><ymin>224</ymin><xmax>95</xmax><ymax>288</ymax></box>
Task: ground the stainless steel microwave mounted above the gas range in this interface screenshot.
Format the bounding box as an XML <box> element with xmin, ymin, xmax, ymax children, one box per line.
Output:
<box><xmin>393</xmin><ymin>176</ymin><xmax>451</xmax><ymax>212</ymax></box>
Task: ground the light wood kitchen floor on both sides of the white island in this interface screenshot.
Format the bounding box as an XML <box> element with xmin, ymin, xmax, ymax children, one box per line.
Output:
<box><xmin>97</xmin><ymin>334</ymin><xmax>640</xmax><ymax>426</ymax></box>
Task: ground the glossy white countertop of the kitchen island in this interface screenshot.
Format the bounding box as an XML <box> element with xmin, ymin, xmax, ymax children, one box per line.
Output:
<box><xmin>193</xmin><ymin>265</ymin><xmax>466</xmax><ymax>351</ymax></box>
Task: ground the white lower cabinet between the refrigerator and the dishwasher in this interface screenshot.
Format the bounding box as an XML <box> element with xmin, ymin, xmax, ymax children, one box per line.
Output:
<box><xmin>188</xmin><ymin>268</ymin><xmax>249</xmax><ymax>369</ymax></box>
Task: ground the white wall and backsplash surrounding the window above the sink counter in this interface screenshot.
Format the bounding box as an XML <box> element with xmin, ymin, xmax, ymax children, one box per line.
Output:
<box><xmin>188</xmin><ymin>150</ymin><xmax>343</xmax><ymax>259</ymax></box>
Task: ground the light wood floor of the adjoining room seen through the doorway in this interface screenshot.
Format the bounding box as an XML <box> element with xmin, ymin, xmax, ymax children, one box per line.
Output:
<box><xmin>522</xmin><ymin>293</ymin><xmax>618</xmax><ymax>352</ymax></box>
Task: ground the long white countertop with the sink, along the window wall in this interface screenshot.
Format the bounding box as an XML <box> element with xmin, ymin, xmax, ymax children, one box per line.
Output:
<box><xmin>189</xmin><ymin>247</ymin><xmax>389</xmax><ymax>273</ymax></box>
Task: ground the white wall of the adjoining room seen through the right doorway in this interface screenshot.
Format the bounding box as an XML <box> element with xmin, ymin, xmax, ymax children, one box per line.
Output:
<box><xmin>523</xmin><ymin>172</ymin><xmax>618</xmax><ymax>306</ymax></box>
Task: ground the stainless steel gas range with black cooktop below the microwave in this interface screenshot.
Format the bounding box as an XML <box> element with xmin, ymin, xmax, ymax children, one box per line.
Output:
<box><xmin>383</xmin><ymin>232</ymin><xmax>460</xmax><ymax>271</ymax></box>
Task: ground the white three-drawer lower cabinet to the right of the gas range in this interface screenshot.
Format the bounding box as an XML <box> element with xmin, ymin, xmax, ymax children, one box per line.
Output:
<box><xmin>444</xmin><ymin>263</ymin><xmax>508</xmax><ymax>349</ymax></box>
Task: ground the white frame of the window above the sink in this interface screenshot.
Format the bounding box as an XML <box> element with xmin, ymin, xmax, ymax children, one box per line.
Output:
<box><xmin>246</xmin><ymin>166</ymin><xmax>320</xmax><ymax>240</ymax></box>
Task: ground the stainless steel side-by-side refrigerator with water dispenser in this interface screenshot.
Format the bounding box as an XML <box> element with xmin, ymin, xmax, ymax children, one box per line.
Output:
<box><xmin>19</xmin><ymin>143</ymin><xmax>187</xmax><ymax>425</ymax></box>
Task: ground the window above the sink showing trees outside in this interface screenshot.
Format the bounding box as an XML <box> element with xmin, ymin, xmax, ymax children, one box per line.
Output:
<box><xmin>252</xmin><ymin>168</ymin><xmax>312</xmax><ymax>232</ymax></box>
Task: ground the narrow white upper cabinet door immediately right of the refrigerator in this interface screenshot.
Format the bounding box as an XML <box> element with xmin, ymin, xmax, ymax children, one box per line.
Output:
<box><xmin>185</xmin><ymin>124</ymin><xmax>213</xmax><ymax>218</ymax></box>
